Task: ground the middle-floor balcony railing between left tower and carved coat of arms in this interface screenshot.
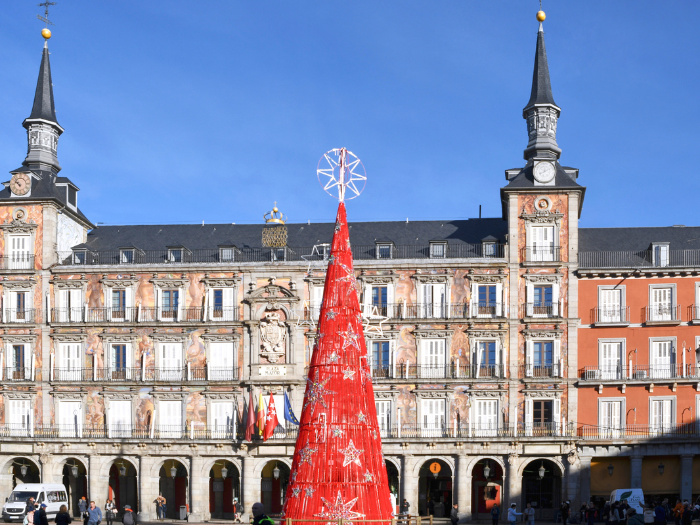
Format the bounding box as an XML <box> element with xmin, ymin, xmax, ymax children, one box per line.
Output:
<box><xmin>50</xmin><ymin>365</ymin><xmax>239</xmax><ymax>382</ymax></box>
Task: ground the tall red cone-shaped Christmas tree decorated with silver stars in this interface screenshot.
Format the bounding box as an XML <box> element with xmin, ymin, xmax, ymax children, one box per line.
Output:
<box><xmin>284</xmin><ymin>202</ymin><xmax>392</xmax><ymax>522</ymax></box>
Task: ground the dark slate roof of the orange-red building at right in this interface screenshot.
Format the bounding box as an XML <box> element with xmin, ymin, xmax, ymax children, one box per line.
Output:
<box><xmin>578</xmin><ymin>226</ymin><xmax>700</xmax><ymax>252</ymax></box>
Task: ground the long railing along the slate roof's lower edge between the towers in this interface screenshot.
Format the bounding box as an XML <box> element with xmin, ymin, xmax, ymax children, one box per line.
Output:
<box><xmin>58</xmin><ymin>243</ymin><xmax>505</xmax><ymax>266</ymax></box>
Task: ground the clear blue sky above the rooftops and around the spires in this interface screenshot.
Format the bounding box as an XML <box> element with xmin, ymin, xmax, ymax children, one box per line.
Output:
<box><xmin>0</xmin><ymin>0</ymin><xmax>700</xmax><ymax>226</ymax></box>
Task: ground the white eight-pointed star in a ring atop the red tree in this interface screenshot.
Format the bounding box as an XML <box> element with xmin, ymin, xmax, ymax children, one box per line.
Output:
<box><xmin>316</xmin><ymin>148</ymin><xmax>367</xmax><ymax>202</ymax></box>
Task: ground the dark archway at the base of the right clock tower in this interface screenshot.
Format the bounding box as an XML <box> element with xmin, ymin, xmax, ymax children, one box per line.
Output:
<box><xmin>522</xmin><ymin>459</ymin><xmax>561</xmax><ymax>521</ymax></box>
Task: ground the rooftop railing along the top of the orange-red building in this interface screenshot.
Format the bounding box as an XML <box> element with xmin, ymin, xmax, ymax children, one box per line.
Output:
<box><xmin>578</xmin><ymin>249</ymin><xmax>700</xmax><ymax>269</ymax></box>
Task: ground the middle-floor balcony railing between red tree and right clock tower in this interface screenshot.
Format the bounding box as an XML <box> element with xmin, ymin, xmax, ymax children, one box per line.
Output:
<box><xmin>372</xmin><ymin>362</ymin><xmax>506</xmax><ymax>380</ymax></box>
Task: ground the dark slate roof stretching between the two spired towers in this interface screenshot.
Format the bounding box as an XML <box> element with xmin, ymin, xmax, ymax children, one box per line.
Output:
<box><xmin>78</xmin><ymin>218</ymin><xmax>507</xmax><ymax>251</ymax></box>
